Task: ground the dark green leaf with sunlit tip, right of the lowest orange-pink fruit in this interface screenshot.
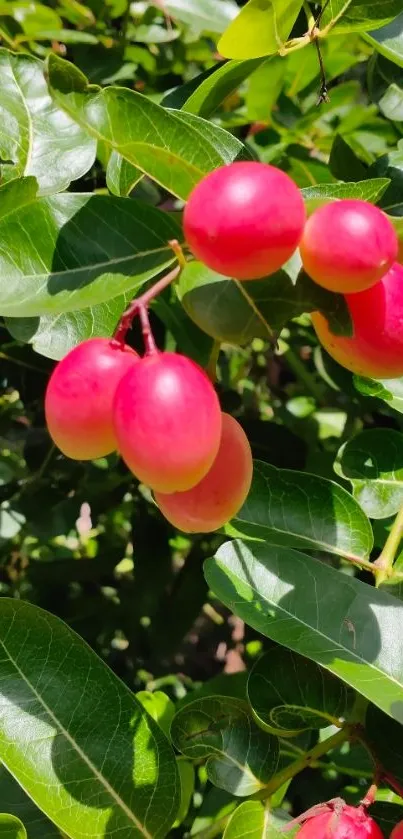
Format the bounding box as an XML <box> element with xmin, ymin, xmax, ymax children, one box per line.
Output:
<box><xmin>232</xmin><ymin>460</ymin><xmax>373</xmax><ymax>560</ymax></box>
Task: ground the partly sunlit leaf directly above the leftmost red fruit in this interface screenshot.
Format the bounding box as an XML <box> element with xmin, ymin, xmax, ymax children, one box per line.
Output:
<box><xmin>4</xmin><ymin>294</ymin><xmax>131</xmax><ymax>361</ymax></box>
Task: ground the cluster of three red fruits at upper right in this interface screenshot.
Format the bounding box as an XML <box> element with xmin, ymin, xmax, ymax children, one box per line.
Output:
<box><xmin>184</xmin><ymin>162</ymin><xmax>403</xmax><ymax>378</ymax></box>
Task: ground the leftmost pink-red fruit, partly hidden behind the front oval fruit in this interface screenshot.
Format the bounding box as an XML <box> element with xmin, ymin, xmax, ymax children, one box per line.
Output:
<box><xmin>45</xmin><ymin>338</ymin><xmax>138</xmax><ymax>460</ymax></box>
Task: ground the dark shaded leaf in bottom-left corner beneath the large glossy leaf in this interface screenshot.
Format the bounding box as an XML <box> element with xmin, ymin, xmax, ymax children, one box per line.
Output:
<box><xmin>0</xmin><ymin>765</ymin><xmax>60</xmax><ymax>839</ymax></box>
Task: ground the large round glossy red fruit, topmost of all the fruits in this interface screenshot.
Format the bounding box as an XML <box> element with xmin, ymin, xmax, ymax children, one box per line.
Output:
<box><xmin>184</xmin><ymin>162</ymin><xmax>306</xmax><ymax>280</ymax></box>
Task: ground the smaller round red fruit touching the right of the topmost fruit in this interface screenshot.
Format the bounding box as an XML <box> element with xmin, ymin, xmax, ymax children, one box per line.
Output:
<box><xmin>300</xmin><ymin>200</ymin><xmax>398</xmax><ymax>293</ymax></box>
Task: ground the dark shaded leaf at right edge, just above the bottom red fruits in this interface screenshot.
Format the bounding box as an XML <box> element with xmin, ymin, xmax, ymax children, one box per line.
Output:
<box><xmin>365</xmin><ymin>702</ymin><xmax>403</xmax><ymax>783</ymax></box>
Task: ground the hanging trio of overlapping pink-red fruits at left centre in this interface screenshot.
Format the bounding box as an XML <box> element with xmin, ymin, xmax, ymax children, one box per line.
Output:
<box><xmin>45</xmin><ymin>338</ymin><xmax>253</xmax><ymax>533</ymax></box>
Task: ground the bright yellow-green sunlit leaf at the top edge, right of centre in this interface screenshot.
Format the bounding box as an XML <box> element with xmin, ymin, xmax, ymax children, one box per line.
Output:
<box><xmin>218</xmin><ymin>0</ymin><xmax>302</xmax><ymax>59</ymax></box>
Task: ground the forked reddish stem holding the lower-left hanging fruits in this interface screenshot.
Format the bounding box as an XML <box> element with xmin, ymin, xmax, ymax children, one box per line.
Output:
<box><xmin>113</xmin><ymin>239</ymin><xmax>186</xmax><ymax>348</ymax></box>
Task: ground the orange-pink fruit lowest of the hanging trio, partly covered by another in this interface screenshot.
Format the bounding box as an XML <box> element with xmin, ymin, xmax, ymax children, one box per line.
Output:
<box><xmin>155</xmin><ymin>414</ymin><xmax>253</xmax><ymax>533</ymax></box>
